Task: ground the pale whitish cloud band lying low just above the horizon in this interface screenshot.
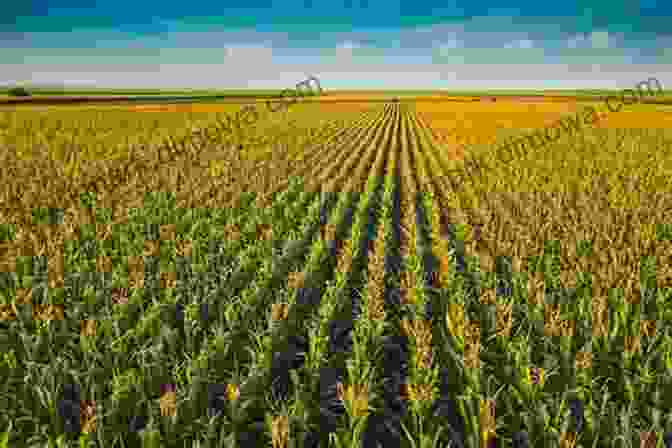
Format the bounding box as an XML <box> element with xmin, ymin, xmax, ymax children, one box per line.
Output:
<box><xmin>2</xmin><ymin>60</ymin><xmax>672</xmax><ymax>91</ymax></box>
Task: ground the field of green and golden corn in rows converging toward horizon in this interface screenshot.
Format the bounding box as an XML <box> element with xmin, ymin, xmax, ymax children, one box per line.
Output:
<box><xmin>0</xmin><ymin>101</ymin><xmax>672</xmax><ymax>448</ymax></box>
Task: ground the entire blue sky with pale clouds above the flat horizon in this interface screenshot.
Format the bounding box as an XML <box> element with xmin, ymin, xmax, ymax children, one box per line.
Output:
<box><xmin>0</xmin><ymin>0</ymin><xmax>672</xmax><ymax>90</ymax></box>
